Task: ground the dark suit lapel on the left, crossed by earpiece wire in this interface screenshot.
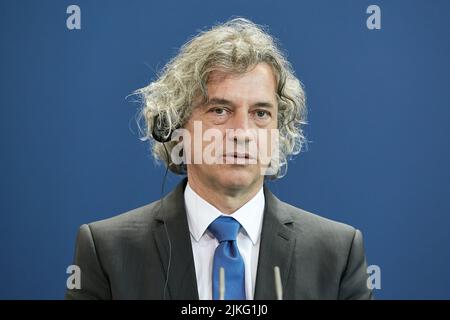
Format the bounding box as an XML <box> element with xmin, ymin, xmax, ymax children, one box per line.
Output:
<box><xmin>154</xmin><ymin>179</ymin><xmax>198</xmax><ymax>300</ymax></box>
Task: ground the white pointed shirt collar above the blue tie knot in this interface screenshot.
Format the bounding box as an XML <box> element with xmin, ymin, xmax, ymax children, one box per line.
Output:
<box><xmin>184</xmin><ymin>181</ymin><xmax>265</xmax><ymax>245</ymax></box>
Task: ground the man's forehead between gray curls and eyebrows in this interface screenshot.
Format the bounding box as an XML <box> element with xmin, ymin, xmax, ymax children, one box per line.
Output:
<box><xmin>207</xmin><ymin>63</ymin><xmax>276</xmax><ymax>103</ymax></box>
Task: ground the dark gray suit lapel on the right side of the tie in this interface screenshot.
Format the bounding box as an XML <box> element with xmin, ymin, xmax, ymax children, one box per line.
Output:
<box><xmin>254</xmin><ymin>185</ymin><xmax>295</xmax><ymax>300</ymax></box>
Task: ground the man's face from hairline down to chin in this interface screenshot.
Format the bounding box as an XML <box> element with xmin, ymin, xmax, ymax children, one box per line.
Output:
<box><xmin>185</xmin><ymin>63</ymin><xmax>278</xmax><ymax>192</ymax></box>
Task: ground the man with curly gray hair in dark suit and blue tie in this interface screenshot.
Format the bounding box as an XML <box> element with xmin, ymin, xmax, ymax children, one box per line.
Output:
<box><xmin>66</xmin><ymin>19</ymin><xmax>372</xmax><ymax>299</ymax></box>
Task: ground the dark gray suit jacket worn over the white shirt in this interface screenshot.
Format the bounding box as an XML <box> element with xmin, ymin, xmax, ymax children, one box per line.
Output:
<box><xmin>66</xmin><ymin>179</ymin><xmax>372</xmax><ymax>299</ymax></box>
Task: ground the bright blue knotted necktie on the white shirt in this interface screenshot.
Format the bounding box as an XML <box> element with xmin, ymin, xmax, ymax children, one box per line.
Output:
<box><xmin>208</xmin><ymin>216</ymin><xmax>245</xmax><ymax>300</ymax></box>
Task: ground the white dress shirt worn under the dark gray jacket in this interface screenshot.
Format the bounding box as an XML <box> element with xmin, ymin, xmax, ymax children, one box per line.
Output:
<box><xmin>184</xmin><ymin>182</ymin><xmax>265</xmax><ymax>300</ymax></box>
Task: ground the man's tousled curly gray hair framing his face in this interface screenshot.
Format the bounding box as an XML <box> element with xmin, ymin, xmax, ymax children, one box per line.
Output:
<box><xmin>135</xmin><ymin>18</ymin><xmax>306</xmax><ymax>178</ymax></box>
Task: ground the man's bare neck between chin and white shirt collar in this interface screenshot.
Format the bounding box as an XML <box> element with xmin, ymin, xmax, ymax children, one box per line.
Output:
<box><xmin>188</xmin><ymin>172</ymin><xmax>263</xmax><ymax>214</ymax></box>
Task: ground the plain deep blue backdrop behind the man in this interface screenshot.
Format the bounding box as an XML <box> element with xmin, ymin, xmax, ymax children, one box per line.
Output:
<box><xmin>0</xmin><ymin>0</ymin><xmax>450</xmax><ymax>299</ymax></box>
